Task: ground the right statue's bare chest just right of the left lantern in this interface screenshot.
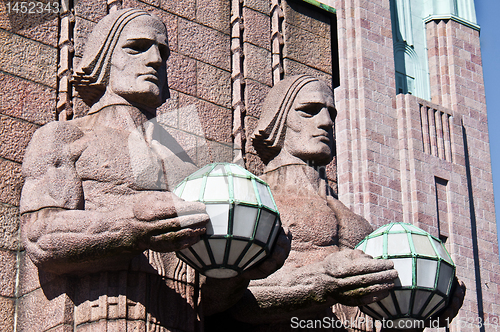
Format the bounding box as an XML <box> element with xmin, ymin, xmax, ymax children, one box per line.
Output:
<box><xmin>274</xmin><ymin>195</ymin><xmax>338</xmax><ymax>246</ymax></box>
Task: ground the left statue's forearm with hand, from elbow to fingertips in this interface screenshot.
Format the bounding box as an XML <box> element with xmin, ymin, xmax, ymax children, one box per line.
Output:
<box><xmin>22</xmin><ymin>191</ymin><xmax>209</xmax><ymax>273</ymax></box>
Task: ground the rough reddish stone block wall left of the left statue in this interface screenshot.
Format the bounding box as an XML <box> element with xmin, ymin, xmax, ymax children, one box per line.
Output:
<box><xmin>0</xmin><ymin>1</ymin><xmax>58</xmax><ymax>331</ymax></box>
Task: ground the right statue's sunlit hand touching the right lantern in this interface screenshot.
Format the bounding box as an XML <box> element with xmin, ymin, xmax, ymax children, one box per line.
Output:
<box><xmin>322</xmin><ymin>249</ymin><xmax>398</xmax><ymax>306</ymax></box>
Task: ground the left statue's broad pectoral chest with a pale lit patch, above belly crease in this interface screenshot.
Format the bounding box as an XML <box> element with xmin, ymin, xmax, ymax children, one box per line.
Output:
<box><xmin>75</xmin><ymin>129</ymin><xmax>165</xmax><ymax>190</ymax></box>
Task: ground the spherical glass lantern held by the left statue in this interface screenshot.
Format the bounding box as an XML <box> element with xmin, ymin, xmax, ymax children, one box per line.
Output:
<box><xmin>174</xmin><ymin>163</ymin><xmax>281</xmax><ymax>278</ymax></box>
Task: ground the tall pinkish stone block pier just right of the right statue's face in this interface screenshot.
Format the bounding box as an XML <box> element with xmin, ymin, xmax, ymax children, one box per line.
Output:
<box><xmin>334</xmin><ymin>0</ymin><xmax>403</xmax><ymax>226</ymax></box>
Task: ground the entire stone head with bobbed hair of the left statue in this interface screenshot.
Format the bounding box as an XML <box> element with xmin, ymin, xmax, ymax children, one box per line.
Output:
<box><xmin>74</xmin><ymin>9</ymin><xmax>170</xmax><ymax>108</ymax></box>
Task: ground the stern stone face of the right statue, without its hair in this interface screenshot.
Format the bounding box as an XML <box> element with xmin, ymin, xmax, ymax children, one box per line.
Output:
<box><xmin>283</xmin><ymin>81</ymin><xmax>337</xmax><ymax>165</ymax></box>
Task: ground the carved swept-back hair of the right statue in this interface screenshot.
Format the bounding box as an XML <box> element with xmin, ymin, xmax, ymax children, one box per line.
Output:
<box><xmin>251</xmin><ymin>75</ymin><xmax>319</xmax><ymax>164</ymax></box>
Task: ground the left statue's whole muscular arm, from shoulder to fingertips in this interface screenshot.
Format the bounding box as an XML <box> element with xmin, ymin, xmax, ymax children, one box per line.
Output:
<box><xmin>20</xmin><ymin>122</ymin><xmax>208</xmax><ymax>273</ymax></box>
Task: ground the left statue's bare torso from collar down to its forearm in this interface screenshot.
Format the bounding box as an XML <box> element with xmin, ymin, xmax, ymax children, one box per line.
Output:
<box><xmin>75</xmin><ymin>123</ymin><xmax>166</xmax><ymax>211</ymax></box>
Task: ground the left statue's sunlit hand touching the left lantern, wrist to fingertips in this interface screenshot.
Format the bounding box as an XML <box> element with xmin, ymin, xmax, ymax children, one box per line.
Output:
<box><xmin>130</xmin><ymin>191</ymin><xmax>209</xmax><ymax>252</ymax></box>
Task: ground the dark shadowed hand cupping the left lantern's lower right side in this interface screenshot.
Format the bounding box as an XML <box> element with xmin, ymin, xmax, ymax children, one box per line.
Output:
<box><xmin>241</xmin><ymin>228</ymin><xmax>291</xmax><ymax>280</ymax></box>
